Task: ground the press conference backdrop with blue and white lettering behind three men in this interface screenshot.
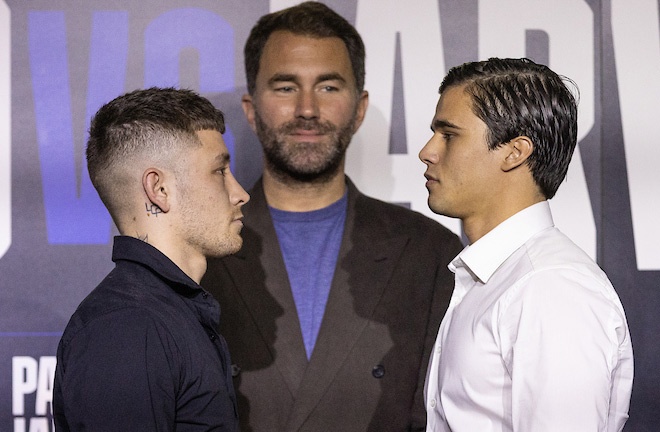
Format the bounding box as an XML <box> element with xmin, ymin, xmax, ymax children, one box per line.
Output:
<box><xmin>0</xmin><ymin>0</ymin><xmax>660</xmax><ymax>432</ymax></box>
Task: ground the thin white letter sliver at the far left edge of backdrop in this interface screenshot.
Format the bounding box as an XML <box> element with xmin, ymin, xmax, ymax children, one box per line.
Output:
<box><xmin>0</xmin><ymin>0</ymin><xmax>12</xmax><ymax>258</ymax></box>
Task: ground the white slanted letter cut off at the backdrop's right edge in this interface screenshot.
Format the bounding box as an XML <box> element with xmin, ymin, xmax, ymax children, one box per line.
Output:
<box><xmin>612</xmin><ymin>0</ymin><xmax>660</xmax><ymax>270</ymax></box>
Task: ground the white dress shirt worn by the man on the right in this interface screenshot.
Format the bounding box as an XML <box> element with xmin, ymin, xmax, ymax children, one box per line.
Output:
<box><xmin>424</xmin><ymin>201</ymin><xmax>633</xmax><ymax>432</ymax></box>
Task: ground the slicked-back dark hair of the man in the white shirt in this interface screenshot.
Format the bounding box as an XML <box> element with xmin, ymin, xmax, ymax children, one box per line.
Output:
<box><xmin>440</xmin><ymin>58</ymin><xmax>578</xmax><ymax>199</ymax></box>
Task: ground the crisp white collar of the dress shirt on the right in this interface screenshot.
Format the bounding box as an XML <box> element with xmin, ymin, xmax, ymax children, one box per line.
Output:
<box><xmin>449</xmin><ymin>201</ymin><xmax>555</xmax><ymax>283</ymax></box>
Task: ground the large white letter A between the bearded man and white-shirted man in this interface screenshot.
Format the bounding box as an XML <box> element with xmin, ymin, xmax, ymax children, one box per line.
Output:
<box><xmin>356</xmin><ymin>0</ymin><xmax>460</xmax><ymax>233</ymax></box>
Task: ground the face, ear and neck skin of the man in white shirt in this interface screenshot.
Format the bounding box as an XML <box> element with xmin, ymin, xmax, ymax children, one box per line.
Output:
<box><xmin>419</xmin><ymin>85</ymin><xmax>545</xmax><ymax>243</ymax></box>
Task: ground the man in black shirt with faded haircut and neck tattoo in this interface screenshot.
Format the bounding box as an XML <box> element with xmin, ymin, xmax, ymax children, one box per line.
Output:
<box><xmin>53</xmin><ymin>88</ymin><xmax>249</xmax><ymax>432</ymax></box>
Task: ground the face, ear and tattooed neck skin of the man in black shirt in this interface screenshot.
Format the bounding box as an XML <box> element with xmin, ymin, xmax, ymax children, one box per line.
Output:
<box><xmin>120</xmin><ymin>130</ymin><xmax>250</xmax><ymax>283</ymax></box>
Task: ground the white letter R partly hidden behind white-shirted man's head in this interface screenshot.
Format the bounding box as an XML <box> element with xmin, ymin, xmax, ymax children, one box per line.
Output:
<box><xmin>479</xmin><ymin>0</ymin><xmax>596</xmax><ymax>258</ymax></box>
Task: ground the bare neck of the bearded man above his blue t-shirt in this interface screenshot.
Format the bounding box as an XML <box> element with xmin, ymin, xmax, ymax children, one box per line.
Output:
<box><xmin>263</xmin><ymin>170</ymin><xmax>346</xmax><ymax>212</ymax></box>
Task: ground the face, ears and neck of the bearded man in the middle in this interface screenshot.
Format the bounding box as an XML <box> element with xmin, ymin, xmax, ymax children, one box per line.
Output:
<box><xmin>242</xmin><ymin>31</ymin><xmax>368</xmax><ymax>211</ymax></box>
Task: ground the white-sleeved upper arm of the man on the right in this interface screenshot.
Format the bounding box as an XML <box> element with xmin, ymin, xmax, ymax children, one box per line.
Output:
<box><xmin>498</xmin><ymin>270</ymin><xmax>632</xmax><ymax>431</ymax></box>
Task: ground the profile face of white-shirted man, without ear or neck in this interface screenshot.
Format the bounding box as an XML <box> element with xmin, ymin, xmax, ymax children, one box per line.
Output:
<box><xmin>419</xmin><ymin>85</ymin><xmax>502</xmax><ymax>222</ymax></box>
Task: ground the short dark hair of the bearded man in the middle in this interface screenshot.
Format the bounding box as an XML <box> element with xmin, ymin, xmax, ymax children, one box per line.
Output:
<box><xmin>244</xmin><ymin>1</ymin><xmax>365</xmax><ymax>94</ymax></box>
